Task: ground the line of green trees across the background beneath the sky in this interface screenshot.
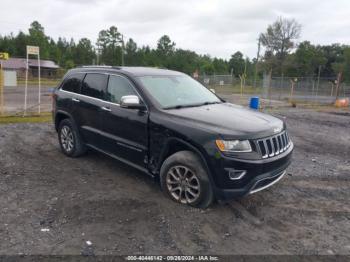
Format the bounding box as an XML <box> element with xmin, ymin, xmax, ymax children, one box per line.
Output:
<box><xmin>0</xmin><ymin>18</ymin><xmax>350</xmax><ymax>82</ymax></box>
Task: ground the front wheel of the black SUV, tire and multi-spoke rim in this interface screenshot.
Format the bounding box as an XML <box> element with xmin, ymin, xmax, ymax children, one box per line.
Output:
<box><xmin>160</xmin><ymin>151</ymin><xmax>214</xmax><ymax>208</ymax></box>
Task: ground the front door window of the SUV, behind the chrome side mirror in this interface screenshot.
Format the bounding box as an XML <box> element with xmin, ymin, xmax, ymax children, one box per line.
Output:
<box><xmin>107</xmin><ymin>76</ymin><xmax>137</xmax><ymax>104</ymax></box>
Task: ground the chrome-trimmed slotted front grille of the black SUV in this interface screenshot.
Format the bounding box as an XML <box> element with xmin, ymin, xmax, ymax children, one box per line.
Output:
<box><xmin>256</xmin><ymin>131</ymin><xmax>291</xmax><ymax>158</ymax></box>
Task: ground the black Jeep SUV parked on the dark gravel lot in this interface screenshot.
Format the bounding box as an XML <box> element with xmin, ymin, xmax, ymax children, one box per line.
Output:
<box><xmin>53</xmin><ymin>67</ymin><xmax>293</xmax><ymax>208</ymax></box>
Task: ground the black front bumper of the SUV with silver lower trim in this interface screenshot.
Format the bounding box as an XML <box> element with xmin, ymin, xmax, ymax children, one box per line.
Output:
<box><xmin>208</xmin><ymin>144</ymin><xmax>293</xmax><ymax>200</ymax></box>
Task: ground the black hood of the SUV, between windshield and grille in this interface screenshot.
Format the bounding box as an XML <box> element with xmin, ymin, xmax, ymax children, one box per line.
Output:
<box><xmin>166</xmin><ymin>103</ymin><xmax>284</xmax><ymax>139</ymax></box>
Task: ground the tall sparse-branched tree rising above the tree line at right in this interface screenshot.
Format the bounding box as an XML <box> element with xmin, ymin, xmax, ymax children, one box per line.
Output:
<box><xmin>260</xmin><ymin>17</ymin><xmax>301</xmax><ymax>74</ymax></box>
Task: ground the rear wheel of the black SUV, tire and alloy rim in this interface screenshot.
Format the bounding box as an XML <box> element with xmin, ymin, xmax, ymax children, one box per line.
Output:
<box><xmin>58</xmin><ymin>118</ymin><xmax>86</xmax><ymax>157</ymax></box>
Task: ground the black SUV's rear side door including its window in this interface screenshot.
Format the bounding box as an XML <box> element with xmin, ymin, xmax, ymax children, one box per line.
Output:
<box><xmin>76</xmin><ymin>73</ymin><xmax>108</xmax><ymax>148</ymax></box>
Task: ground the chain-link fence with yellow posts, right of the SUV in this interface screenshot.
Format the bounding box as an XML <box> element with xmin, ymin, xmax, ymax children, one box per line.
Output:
<box><xmin>198</xmin><ymin>75</ymin><xmax>350</xmax><ymax>104</ymax></box>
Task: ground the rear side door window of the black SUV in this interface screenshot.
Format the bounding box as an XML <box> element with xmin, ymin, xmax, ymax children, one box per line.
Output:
<box><xmin>81</xmin><ymin>74</ymin><xmax>108</xmax><ymax>99</ymax></box>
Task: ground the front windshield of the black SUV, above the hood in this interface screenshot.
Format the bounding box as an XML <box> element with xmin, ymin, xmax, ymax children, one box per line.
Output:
<box><xmin>139</xmin><ymin>75</ymin><xmax>221</xmax><ymax>109</ymax></box>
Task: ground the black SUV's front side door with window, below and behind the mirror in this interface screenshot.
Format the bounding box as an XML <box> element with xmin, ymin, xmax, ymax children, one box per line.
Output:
<box><xmin>101</xmin><ymin>75</ymin><xmax>148</xmax><ymax>168</ymax></box>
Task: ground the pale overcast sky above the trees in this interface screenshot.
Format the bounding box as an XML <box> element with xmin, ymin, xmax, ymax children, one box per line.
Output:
<box><xmin>0</xmin><ymin>0</ymin><xmax>350</xmax><ymax>58</ymax></box>
